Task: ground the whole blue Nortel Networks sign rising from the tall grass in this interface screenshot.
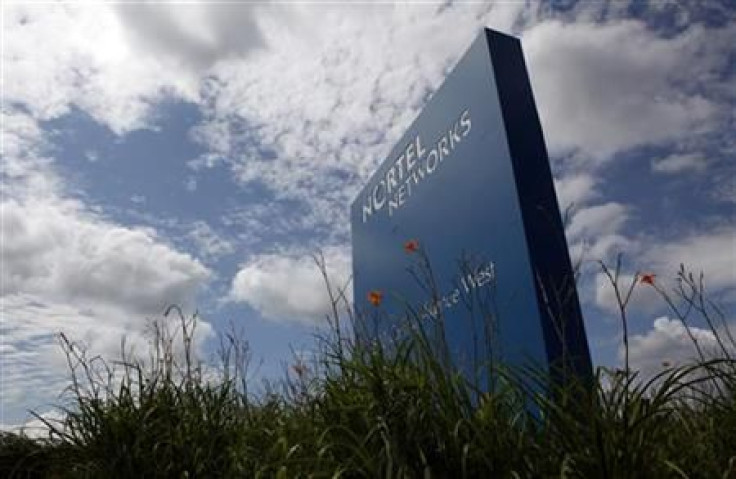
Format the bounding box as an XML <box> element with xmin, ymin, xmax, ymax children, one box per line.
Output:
<box><xmin>351</xmin><ymin>29</ymin><xmax>591</xmax><ymax>382</ymax></box>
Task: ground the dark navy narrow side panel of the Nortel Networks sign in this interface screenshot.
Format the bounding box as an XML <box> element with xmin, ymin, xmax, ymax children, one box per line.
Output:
<box><xmin>486</xmin><ymin>30</ymin><xmax>592</xmax><ymax>377</ymax></box>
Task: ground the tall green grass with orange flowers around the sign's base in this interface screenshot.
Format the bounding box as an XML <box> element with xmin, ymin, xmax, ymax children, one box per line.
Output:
<box><xmin>0</xmin><ymin>260</ymin><xmax>736</xmax><ymax>478</ymax></box>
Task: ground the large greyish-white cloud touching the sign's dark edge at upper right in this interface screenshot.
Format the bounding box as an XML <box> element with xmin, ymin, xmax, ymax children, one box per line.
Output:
<box><xmin>523</xmin><ymin>21</ymin><xmax>733</xmax><ymax>161</ymax></box>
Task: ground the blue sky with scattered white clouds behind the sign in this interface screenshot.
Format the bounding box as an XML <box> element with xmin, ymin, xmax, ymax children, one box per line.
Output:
<box><xmin>0</xmin><ymin>0</ymin><xmax>736</xmax><ymax>427</ymax></box>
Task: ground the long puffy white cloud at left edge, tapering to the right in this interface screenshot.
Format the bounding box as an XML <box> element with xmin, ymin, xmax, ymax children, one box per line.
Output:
<box><xmin>1</xmin><ymin>199</ymin><xmax>210</xmax><ymax>314</ymax></box>
